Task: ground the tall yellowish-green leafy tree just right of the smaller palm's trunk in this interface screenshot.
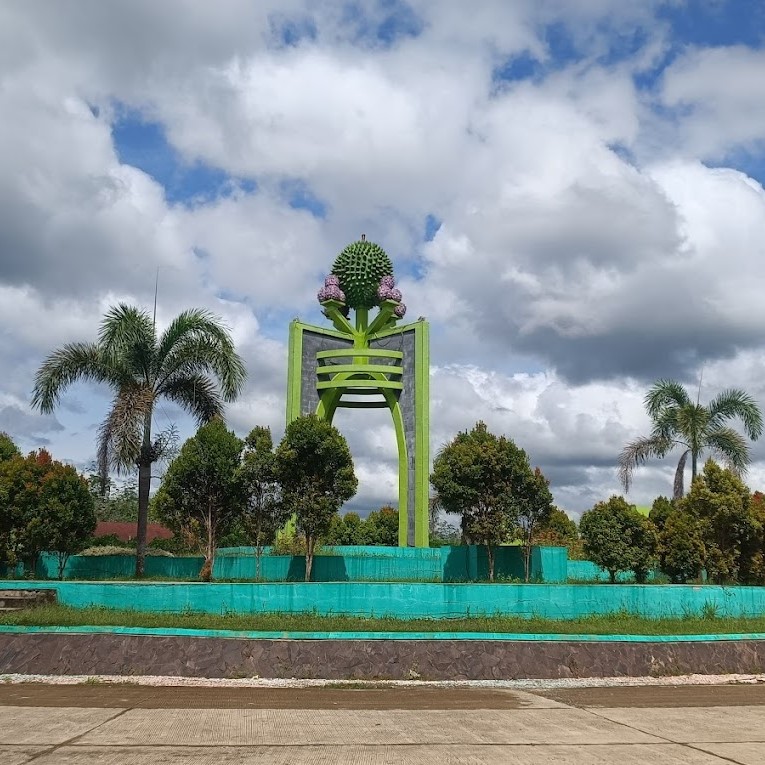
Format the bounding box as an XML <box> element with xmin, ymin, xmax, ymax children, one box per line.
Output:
<box><xmin>678</xmin><ymin>460</ymin><xmax>761</xmax><ymax>584</ymax></box>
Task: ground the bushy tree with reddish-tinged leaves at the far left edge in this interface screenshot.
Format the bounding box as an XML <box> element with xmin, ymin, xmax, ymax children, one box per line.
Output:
<box><xmin>0</xmin><ymin>449</ymin><xmax>96</xmax><ymax>579</ymax></box>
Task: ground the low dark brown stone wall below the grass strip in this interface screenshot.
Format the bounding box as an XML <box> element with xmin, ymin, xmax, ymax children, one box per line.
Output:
<box><xmin>0</xmin><ymin>633</ymin><xmax>765</xmax><ymax>680</ymax></box>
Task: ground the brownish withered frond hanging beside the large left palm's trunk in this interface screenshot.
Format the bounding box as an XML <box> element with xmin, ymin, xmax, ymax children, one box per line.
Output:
<box><xmin>98</xmin><ymin>383</ymin><xmax>154</xmax><ymax>480</ymax></box>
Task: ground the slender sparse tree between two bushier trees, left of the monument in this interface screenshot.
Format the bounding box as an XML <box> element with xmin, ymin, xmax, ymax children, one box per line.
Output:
<box><xmin>239</xmin><ymin>426</ymin><xmax>289</xmax><ymax>579</ymax></box>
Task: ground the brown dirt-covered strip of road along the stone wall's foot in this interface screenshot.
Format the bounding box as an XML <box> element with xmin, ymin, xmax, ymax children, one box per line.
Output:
<box><xmin>0</xmin><ymin>682</ymin><xmax>765</xmax><ymax>710</ymax></box>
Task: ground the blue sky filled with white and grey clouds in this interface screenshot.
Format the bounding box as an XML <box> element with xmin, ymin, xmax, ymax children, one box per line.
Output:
<box><xmin>0</xmin><ymin>0</ymin><xmax>765</xmax><ymax>516</ymax></box>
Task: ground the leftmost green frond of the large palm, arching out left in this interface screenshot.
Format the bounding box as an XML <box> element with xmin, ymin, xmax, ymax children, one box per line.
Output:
<box><xmin>32</xmin><ymin>343</ymin><xmax>115</xmax><ymax>414</ymax></box>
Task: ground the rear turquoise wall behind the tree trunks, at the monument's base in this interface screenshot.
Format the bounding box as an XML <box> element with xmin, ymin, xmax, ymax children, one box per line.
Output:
<box><xmin>19</xmin><ymin>545</ymin><xmax>567</xmax><ymax>582</ymax></box>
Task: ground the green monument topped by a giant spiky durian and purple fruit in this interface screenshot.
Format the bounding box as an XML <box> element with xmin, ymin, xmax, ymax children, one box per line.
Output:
<box><xmin>287</xmin><ymin>234</ymin><xmax>430</xmax><ymax>547</ymax></box>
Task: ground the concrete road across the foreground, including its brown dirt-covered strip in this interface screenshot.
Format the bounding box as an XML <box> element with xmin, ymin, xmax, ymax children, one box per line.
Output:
<box><xmin>0</xmin><ymin>684</ymin><xmax>765</xmax><ymax>765</ymax></box>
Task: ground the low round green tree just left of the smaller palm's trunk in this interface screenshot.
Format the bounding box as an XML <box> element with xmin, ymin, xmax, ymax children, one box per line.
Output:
<box><xmin>579</xmin><ymin>496</ymin><xmax>658</xmax><ymax>583</ymax></box>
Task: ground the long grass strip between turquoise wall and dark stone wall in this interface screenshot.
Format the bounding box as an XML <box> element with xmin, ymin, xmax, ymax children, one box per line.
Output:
<box><xmin>0</xmin><ymin>605</ymin><xmax>765</xmax><ymax>635</ymax></box>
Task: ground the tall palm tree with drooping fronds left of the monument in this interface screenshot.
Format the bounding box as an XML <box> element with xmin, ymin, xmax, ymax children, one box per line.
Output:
<box><xmin>32</xmin><ymin>304</ymin><xmax>245</xmax><ymax>577</ymax></box>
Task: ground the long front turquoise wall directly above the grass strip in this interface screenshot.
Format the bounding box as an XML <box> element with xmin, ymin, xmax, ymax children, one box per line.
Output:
<box><xmin>2</xmin><ymin>581</ymin><xmax>765</xmax><ymax>619</ymax></box>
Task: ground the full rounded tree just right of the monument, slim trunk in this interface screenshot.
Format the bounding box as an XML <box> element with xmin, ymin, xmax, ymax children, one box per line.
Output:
<box><xmin>430</xmin><ymin>422</ymin><xmax>533</xmax><ymax>582</ymax></box>
